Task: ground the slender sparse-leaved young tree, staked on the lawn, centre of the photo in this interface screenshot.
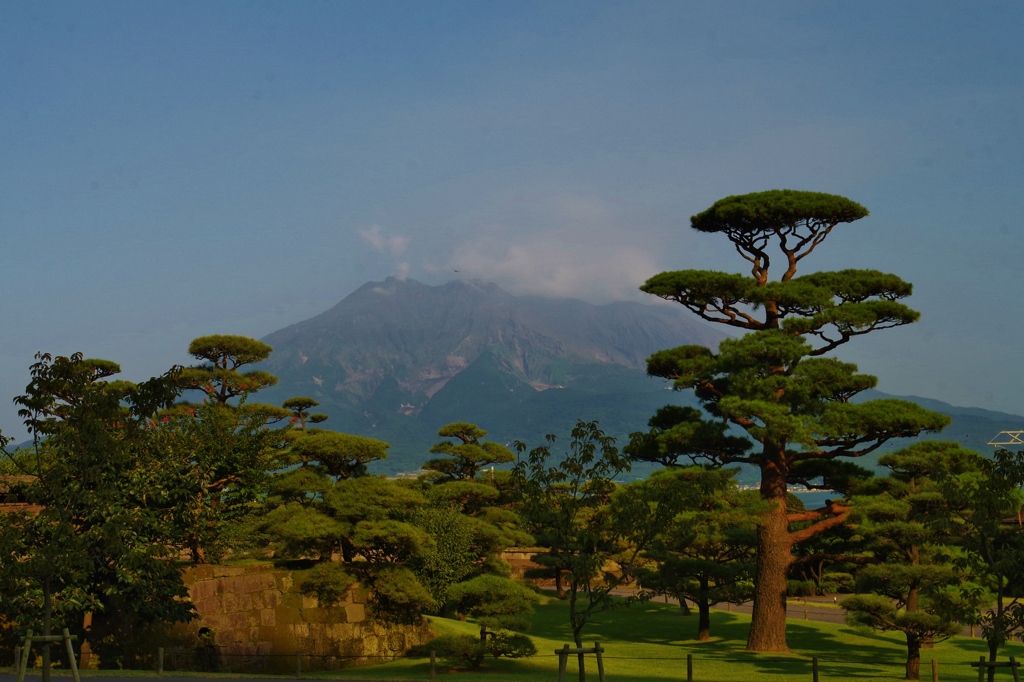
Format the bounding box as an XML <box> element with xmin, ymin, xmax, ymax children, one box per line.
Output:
<box><xmin>513</xmin><ymin>422</ymin><xmax>678</xmax><ymax>655</ymax></box>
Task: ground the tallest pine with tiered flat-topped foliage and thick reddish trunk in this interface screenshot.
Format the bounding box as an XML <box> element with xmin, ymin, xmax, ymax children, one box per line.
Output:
<box><xmin>641</xmin><ymin>189</ymin><xmax>949</xmax><ymax>651</ymax></box>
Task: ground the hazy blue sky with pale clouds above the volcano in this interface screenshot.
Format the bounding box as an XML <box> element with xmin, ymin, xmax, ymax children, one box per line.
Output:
<box><xmin>0</xmin><ymin>0</ymin><xmax>1024</xmax><ymax>435</ymax></box>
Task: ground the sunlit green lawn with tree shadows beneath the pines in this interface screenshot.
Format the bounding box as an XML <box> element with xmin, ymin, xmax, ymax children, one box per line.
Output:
<box><xmin>317</xmin><ymin>599</ymin><xmax>1024</xmax><ymax>682</ymax></box>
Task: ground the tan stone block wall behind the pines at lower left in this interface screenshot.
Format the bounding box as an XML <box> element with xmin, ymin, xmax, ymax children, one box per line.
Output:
<box><xmin>176</xmin><ymin>564</ymin><xmax>432</xmax><ymax>672</ymax></box>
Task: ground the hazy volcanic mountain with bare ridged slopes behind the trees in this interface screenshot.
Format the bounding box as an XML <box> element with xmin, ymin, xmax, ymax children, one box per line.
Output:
<box><xmin>253</xmin><ymin>278</ymin><xmax>1024</xmax><ymax>475</ymax></box>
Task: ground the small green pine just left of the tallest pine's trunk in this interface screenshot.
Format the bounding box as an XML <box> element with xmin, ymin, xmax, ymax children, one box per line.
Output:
<box><xmin>634</xmin><ymin>467</ymin><xmax>763</xmax><ymax>641</ymax></box>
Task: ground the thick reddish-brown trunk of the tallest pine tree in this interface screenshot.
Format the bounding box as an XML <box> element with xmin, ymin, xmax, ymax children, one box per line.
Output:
<box><xmin>746</xmin><ymin>454</ymin><xmax>793</xmax><ymax>651</ymax></box>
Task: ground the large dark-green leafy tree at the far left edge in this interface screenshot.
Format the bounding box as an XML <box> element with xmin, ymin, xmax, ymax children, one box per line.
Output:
<box><xmin>0</xmin><ymin>354</ymin><xmax>194</xmax><ymax>679</ymax></box>
